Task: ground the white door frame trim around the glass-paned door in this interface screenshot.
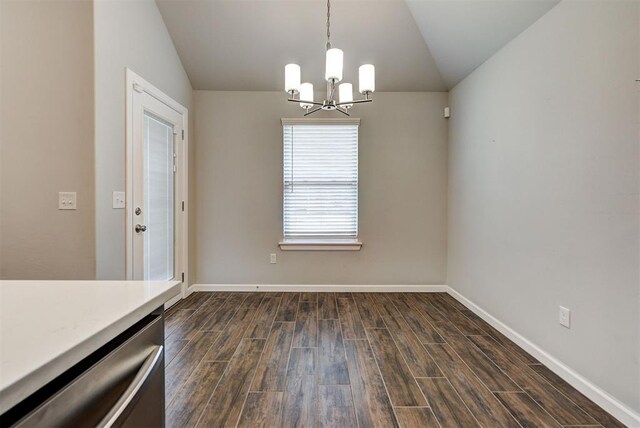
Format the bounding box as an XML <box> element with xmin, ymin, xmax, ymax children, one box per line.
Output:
<box><xmin>125</xmin><ymin>68</ymin><xmax>189</xmax><ymax>303</ymax></box>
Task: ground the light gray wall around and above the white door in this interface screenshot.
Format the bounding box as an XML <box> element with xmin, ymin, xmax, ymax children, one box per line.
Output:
<box><xmin>94</xmin><ymin>0</ymin><xmax>194</xmax><ymax>279</ymax></box>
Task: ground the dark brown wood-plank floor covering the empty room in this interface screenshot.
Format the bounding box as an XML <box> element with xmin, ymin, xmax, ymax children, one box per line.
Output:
<box><xmin>165</xmin><ymin>292</ymin><xmax>624</xmax><ymax>428</ymax></box>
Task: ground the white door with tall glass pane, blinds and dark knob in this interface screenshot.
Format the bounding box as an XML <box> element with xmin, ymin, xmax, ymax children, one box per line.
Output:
<box><xmin>127</xmin><ymin>70</ymin><xmax>186</xmax><ymax>304</ymax></box>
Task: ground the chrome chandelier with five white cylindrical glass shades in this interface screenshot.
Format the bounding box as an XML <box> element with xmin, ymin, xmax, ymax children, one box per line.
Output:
<box><xmin>284</xmin><ymin>0</ymin><xmax>376</xmax><ymax>116</ymax></box>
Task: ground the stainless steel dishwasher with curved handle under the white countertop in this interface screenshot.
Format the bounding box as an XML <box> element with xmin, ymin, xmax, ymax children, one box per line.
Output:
<box><xmin>0</xmin><ymin>308</ymin><xmax>164</xmax><ymax>428</ymax></box>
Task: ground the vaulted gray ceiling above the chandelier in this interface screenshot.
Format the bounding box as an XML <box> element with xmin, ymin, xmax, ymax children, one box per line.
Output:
<box><xmin>156</xmin><ymin>0</ymin><xmax>559</xmax><ymax>91</ymax></box>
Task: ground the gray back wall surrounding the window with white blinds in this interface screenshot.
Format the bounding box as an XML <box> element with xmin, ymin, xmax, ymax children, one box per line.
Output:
<box><xmin>194</xmin><ymin>91</ymin><xmax>447</xmax><ymax>284</ymax></box>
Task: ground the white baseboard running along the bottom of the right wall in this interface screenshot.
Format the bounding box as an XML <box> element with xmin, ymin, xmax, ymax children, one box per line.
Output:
<box><xmin>447</xmin><ymin>287</ymin><xmax>640</xmax><ymax>428</ymax></box>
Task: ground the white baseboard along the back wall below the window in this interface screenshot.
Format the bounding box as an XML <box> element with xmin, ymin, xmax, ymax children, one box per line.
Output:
<box><xmin>190</xmin><ymin>284</ymin><xmax>449</xmax><ymax>293</ymax></box>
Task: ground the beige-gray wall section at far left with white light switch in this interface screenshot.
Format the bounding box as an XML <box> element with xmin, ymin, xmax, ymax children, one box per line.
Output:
<box><xmin>0</xmin><ymin>0</ymin><xmax>95</xmax><ymax>279</ymax></box>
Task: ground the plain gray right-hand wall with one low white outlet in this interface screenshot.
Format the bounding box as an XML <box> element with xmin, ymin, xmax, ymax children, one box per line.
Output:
<box><xmin>448</xmin><ymin>1</ymin><xmax>640</xmax><ymax>411</ymax></box>
